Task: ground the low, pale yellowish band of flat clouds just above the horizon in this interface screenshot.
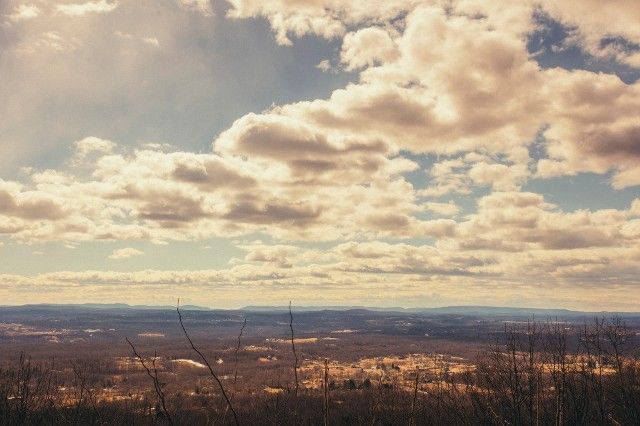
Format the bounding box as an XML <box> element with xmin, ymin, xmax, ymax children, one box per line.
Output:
<box><xmin>5</xmin><ymin>235</ymin><xmax>640</xmax><ymax>309</ymax></box>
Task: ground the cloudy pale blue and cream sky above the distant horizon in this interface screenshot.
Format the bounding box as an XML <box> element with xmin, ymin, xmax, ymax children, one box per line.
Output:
<box><xmin>0</xmin><ymin>0</ymin><xmax>640</xmax><ymax>311</ymax></box>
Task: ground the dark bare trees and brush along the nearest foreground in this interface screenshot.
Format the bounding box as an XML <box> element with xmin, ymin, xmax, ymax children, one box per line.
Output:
<box><xmin>0</xmin><ymin>318</ymin><xmax>640</xmax><ymax>425</ymax></box>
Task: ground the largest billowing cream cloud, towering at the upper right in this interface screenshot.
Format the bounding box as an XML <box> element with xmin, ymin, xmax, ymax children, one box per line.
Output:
<box><xmin>3</xmin><ymin>0</ymin><xmax>640</xmax><ymax>188</ymax></box>
